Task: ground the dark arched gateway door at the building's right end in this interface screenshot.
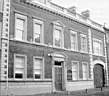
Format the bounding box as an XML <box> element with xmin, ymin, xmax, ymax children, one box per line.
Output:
<box><xmin>93</xmin><ymin>64</ymin><xmax>105</xmax><ymax>88</ymax></box>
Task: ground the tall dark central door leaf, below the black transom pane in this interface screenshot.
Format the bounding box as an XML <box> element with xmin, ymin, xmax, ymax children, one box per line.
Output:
<box><xmin>55</xmin><ymin>67</ymin><xmax>63</xmax><ymax>91</ymax></box>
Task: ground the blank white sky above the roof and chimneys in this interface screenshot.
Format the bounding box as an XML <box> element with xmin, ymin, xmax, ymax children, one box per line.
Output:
<box><xmin>52</xmin><ymin>0</ymin><xmax>109</xmax><ymax>28</ymax></box>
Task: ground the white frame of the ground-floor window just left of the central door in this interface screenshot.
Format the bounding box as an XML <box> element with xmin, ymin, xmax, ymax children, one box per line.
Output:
<box><xmin>33</xmin><ymin>56</ymin><xmax>44</xmax><ymax>81</ymax></box>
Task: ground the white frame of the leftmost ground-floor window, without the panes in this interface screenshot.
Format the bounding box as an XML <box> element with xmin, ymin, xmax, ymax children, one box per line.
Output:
<box><xmin>14</xmin><ymin>54</ymin><xmax>27</xmax><ymax>80</ymax></box>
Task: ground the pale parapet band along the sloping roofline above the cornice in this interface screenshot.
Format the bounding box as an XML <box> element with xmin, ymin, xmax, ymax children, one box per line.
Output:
<box><xmin>27</xmin><ymin>1</ymin><xmax>104</xmax><ymax>32</ymax></box>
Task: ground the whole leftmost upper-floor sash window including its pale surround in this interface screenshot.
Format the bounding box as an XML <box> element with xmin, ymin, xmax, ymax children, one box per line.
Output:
<box><xmin>15</xmin><ymin>14</ymin><xmax>27</xmax><ymax>40</ymax></box>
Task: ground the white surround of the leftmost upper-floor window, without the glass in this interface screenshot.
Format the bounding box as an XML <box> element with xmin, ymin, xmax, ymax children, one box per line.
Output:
<box><xmin>14</xmin><ymin>13</ymin><xmax>27</xmax><ymax>41</ymax></box>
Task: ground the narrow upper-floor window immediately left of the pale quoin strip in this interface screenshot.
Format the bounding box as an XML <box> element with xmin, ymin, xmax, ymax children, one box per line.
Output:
<box><xmin>80</xmin><ymin>34</ymin><xmax>87</xmax><ymax>52</ymax></box>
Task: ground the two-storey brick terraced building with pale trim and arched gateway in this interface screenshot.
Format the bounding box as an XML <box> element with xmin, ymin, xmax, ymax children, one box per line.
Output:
<box><xmin>0</xmin><ymin>0</ymin><xmax>108</xmax><ymax>95</ymax></box>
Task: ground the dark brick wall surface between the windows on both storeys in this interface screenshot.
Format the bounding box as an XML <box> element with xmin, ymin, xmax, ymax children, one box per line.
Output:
<box><xmin>9</xmin><ymin>0</ymin><xmax>102</xmax><ymax>81</ymax></box>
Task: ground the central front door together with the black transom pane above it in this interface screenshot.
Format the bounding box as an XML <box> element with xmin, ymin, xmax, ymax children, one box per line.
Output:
<box><xmin>54</xmin><ymin>61</ymin><xmax>63</xmax><ymax>91</ymax></box>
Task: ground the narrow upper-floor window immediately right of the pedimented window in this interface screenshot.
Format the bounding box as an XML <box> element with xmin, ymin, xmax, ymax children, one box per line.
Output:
<box><xmin>71</xmin><ymin>30</ymin><xmax>78</xmax><ymax>50</ymax></box>
